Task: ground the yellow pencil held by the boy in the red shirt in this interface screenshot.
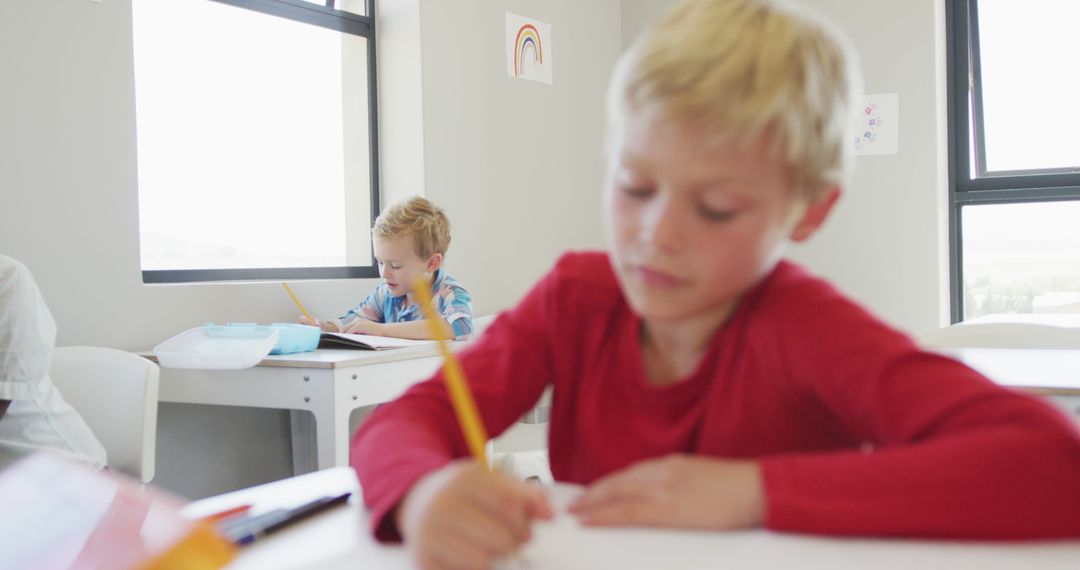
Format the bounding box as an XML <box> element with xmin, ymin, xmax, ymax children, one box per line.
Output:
<box><xmin>413</xmin><ymin>277</ymin><xmax>490</xmax><ymax>469</ymax></box>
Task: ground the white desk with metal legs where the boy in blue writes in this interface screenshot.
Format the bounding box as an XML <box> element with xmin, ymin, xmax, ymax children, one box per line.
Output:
<box><xmin>152</xmin><ymin>344</ymin><xmax>442</xmax><ymax>473</ymax></box>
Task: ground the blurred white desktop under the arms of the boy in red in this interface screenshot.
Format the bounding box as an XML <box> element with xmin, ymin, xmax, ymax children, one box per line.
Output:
<box><xmin>185</xmin><ymin>467</ymin><xmax>1080</xmax><ymax>570</ymax></box>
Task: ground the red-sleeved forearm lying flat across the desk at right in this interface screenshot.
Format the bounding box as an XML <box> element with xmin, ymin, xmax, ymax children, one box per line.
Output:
<box><xmin>761</xmin><ymin>422</ymin><xmax>1080</xmax><ymax>540</ymax></box>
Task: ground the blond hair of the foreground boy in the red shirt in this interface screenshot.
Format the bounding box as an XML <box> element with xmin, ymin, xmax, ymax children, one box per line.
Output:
<box><xmin>608</xmin><ymin>0</ymin><xmax>861</xmax><ymax>200</ymax></box>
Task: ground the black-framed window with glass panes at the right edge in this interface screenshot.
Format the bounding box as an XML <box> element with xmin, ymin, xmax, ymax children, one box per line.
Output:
<box><xmin>946</xmin><ymin>0</ymin><xmax>1080</xmax><ymax>322</ymax></box>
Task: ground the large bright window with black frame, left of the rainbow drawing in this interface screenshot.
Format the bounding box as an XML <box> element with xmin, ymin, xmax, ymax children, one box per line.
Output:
<box><xmin>132</xmin><ymin>0</ymin><xmax>379</xmax><ymax>283</ymax></box>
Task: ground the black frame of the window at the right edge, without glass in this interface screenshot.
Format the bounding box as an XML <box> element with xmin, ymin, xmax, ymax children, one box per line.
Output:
<box><xmin>945</xmin><ymin>0</ymin><xmax>1080</xmax><ymax>323</ymax></box>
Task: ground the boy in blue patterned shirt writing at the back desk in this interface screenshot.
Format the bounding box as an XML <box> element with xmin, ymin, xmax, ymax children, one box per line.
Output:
<box><xmin>300</xmin><ymin>196</ymin><xmax>473</xmax><ymax>340</ymax></box>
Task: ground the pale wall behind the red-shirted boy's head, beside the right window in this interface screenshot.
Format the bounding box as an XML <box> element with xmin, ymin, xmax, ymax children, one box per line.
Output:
<box><xmin>622</xmin><ymin>0</ymin><xmax>948</xmax><ymax>331</ymax></box>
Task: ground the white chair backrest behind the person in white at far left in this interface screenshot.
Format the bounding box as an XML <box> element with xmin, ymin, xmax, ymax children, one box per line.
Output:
<box><xmin>50</xmin><ymin>347</ymin><xmax>160</xmax><ymax>483</ymax></box>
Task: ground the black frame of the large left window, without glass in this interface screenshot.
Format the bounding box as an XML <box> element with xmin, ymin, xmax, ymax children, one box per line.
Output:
<box><xmin>143</xmin><ymin>0</ymin><xmax>380</xmax><ymax>284</ymax></box>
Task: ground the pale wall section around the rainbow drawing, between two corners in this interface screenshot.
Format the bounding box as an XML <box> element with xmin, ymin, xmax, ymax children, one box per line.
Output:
<box><xmin>421</xmin><ymin>0</ymin><xmax>621</xmax><ymax>313</ymax></box>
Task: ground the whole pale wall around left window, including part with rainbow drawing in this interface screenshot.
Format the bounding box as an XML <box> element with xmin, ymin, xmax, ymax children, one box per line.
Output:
<box><xmin>0</xmin><ymin>0</ymin><xmax>621</xmax><ymax>496</ymax></box>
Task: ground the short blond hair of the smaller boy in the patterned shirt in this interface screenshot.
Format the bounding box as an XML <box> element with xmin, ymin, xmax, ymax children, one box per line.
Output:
<box><xmin>372</xmin><ymin>196</ymin><xmax>450</xmax><ymax>259</ymax></box>
